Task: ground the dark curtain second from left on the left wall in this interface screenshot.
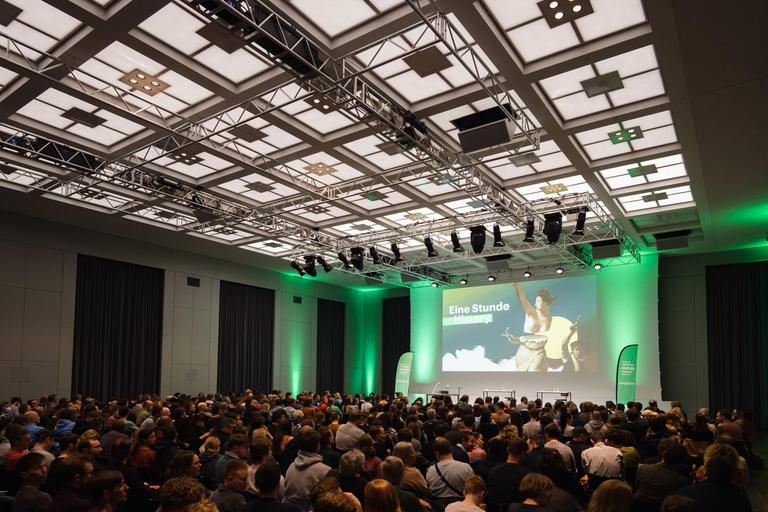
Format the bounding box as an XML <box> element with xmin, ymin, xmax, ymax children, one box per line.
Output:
<box><xmin>216</xmin><ymin>281</ymin><xmax>275</xmax><ymax>393</ymax></box>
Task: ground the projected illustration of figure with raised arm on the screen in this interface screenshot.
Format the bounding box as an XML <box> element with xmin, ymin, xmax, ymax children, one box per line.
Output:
<box><xmin>504</xmin><ymin>283</ymin><xmax>578</xmax><ymax>372</ymax></box>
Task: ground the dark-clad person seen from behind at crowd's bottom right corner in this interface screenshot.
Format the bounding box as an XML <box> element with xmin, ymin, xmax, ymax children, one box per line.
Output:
<box><xmin>677</xmin><ymin>455</ymin><xmax>752</xmax><ymax>512</ymax></box>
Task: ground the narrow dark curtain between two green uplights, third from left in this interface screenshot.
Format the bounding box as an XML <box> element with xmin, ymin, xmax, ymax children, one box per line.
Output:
<box><xmin>316</xmin><ymin>299</ymin><xmax>346</xmax><ymax>392</ymax></box>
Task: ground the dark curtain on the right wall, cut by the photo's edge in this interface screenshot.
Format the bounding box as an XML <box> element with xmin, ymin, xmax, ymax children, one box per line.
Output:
<box><xmin>706</xmin><ymin>262</ymin><xmax>768</xmax><ymax>426</ymax></box>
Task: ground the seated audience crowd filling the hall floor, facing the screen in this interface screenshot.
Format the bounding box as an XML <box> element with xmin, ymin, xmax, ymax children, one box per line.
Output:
<box><xmin>0</xmin><ymin>390</ymin><xmax>761</xmax><ymax>512</ymax></box>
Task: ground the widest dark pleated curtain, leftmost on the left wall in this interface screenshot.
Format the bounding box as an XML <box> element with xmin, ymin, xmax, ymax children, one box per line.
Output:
<box><xmin>72</xmin><ymin>254</ymin><xmax>164</xmax><ymax>400</ymax></box>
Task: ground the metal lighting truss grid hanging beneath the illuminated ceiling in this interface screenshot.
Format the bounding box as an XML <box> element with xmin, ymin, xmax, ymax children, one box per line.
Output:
<box><xmin>0</xmin><ymin>0</ymin><xmax>639</xmax><ymax>284</ymax></box>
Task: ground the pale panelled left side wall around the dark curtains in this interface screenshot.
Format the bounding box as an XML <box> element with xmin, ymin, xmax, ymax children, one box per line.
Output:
<box><xmin>0</xmin><ymin>212</ymin><xmax>354</xmax><ymax>399</ymax></box>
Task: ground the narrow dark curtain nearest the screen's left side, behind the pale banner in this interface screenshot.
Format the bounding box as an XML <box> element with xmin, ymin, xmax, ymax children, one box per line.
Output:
<box><xmin>381</xmin><ymin>297</ymin><xmax>411</xmax><ymax>395</ymax></box>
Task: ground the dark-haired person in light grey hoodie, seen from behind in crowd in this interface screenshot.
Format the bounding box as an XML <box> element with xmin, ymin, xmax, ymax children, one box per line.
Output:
<box><xmin>285</xmin><ymin>430</ymin><xmax>331</xmax><ymax>511</ymax></box>
